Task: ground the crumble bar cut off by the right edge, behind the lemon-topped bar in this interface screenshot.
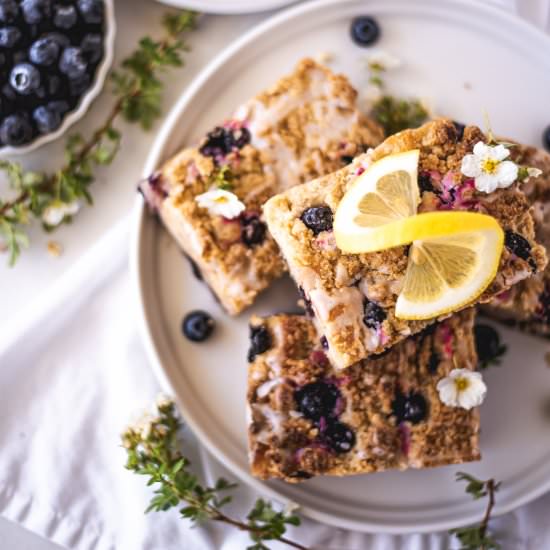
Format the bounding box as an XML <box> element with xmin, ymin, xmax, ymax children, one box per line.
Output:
<box><xmin>483</xmin><ymin>145</ymin><xmax>550</xmax><ymax>337</ymax></box>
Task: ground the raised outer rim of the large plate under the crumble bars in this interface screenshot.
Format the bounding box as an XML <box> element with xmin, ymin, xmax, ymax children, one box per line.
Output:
<box><xmin>129</xmin><ymin>0</ymin><xmax>550</xmax><ymax>534</ymax></box>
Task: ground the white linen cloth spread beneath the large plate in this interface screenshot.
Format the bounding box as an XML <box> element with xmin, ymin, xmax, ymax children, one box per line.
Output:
<box><xmin>0</xmin><ymin>0</ymin><xmax>550</xmax><ymax>550</ymax></box>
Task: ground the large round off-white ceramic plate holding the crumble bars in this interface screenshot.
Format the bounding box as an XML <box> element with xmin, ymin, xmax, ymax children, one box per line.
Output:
<box><xmin>133</xmin><ymin>0</ymin><xmax>550</xmax><ymax>533</ymax></box>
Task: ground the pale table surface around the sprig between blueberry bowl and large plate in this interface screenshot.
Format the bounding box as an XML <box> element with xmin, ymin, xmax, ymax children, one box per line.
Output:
<box><xmin>0</xmin><ymin>0</ymin><xmax>272</xmax><ymax>550</ymax></box>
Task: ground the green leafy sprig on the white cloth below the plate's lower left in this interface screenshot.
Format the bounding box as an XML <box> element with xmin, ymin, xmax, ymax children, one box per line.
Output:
<box><xmin>122</xmin><ymin>399</ymin><xmax>307</xmax><ymax>550</ymax></box>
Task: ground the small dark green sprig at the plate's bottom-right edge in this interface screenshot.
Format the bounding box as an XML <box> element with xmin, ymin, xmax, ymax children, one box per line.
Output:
<box><xmin>449</xmin><ymin>472</ymin><xmax>500</xmax><ymax>550</ymax></box>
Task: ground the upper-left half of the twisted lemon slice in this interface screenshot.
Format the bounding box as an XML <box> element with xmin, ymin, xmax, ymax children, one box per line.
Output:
<box><xmin>334</xmin><ymin>150</ymin><xmax>420</xmax><ymax>253</ymax></box>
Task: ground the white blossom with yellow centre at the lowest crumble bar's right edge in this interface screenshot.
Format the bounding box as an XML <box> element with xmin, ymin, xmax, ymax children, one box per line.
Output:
<box><xmin>437</xmin><ymin>369</ymin><xmax>487</xmax><ymax>410</ymax></box>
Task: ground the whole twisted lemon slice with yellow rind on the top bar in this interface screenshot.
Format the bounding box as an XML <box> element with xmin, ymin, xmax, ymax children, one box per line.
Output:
<box><xmin>334</xmin><ymin>150</ymin><xmax>504</xmax><ymax>320</ymax></box>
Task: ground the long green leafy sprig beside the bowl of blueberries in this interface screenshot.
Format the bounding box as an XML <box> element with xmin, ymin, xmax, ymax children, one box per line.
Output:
<box><xmin>0</xmin><ymin>10</ymin><xmax>197</xmax><ymax>265</ymax></box>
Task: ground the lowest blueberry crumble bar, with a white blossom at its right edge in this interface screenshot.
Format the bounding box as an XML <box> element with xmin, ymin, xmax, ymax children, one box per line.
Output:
<box><xmin>247</xmin><ymin>308</ymin><xmax>480</xmax><ymax>482</ymax></box>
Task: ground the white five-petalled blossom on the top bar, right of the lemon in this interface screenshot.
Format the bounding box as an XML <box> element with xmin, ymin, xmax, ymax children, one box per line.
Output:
<box><xmin>461</xmin><ymin>141</ymin><xmax>518</xmax><ymax>193</ymax></box>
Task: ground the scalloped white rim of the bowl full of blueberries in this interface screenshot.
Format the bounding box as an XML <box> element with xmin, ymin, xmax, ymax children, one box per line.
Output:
<box><xmin>0</xmin><ymin>0</ymin><xmax>116</xmax><ymax>157</ymax></box>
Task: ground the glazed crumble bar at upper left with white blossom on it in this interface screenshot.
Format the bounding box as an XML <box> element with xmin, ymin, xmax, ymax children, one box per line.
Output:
<box><xmin>140</xmin><ymin>59</ymin><xmax>383</xmax><ymax>314</ymax></box>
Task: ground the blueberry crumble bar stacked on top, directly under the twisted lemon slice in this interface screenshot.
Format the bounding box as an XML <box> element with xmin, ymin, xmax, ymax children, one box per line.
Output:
<box><xmin>264</xmin><ymin>119</ymin><xmax>546</xmax><ymax>368</ymax></box>
